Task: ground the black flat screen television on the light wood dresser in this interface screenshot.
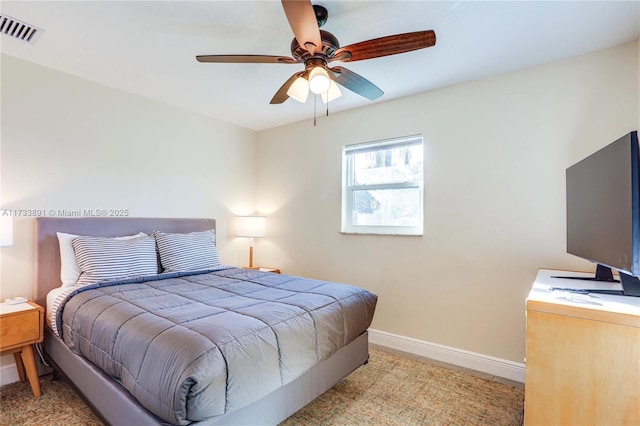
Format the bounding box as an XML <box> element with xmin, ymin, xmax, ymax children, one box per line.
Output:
<box><xmin>566</xmin><ymin>131</ymin><xmax>640</xmax><ymax>296</ymax></box>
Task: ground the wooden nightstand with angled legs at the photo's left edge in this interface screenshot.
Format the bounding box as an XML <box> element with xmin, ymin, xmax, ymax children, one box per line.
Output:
<box><xmin>0</xmin><ymin>302</ymin><xmax>44</xmax><ymax>398</ymax></box>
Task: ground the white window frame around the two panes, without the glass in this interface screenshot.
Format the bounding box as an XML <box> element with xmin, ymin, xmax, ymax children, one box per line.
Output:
<box><xmin>341</xmin><ymin>135</ymin><xmax>424</xmax><ymax>236</ymax></box>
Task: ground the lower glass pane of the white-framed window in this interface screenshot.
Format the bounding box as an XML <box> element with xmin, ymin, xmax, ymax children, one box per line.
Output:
<box><xmin>352</xmin><ymin>187</ymin><xmax>422</xmax><ymax>226</ymax></box>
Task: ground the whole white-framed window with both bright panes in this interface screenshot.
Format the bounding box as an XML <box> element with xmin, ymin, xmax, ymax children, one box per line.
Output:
<box><xmin>342</xmin><ymin>135</ymin><xmax>424</xmax><ymax>235</ymax></box>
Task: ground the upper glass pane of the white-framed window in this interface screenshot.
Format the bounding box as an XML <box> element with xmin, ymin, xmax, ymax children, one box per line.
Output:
<box><xmin>351</xmin><ymin>144</ymin><xmax>422</xmax><ymax>185</ymax></box>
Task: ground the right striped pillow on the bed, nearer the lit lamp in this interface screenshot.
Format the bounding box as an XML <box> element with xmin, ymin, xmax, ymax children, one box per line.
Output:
<box><xmin>153</xmin><ymin>229</ymin><xmax>221</xmax><ymax>272</ymax></box>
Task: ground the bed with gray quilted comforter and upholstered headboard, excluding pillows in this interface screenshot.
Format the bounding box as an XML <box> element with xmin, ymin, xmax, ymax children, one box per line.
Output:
<box><xmin>34</xmin><ymin>218</ymin><xmax>377</xmax><ymax>425</ymax></box>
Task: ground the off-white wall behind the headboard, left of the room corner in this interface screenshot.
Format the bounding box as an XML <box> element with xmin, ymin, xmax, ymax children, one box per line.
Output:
<box><xmin>0</xmin><ymin>55</ymin><xmax>257</xmax><ymax>370</ymax></box>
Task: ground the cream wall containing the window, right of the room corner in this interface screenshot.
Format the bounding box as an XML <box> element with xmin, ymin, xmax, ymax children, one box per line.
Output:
<box><xmin>256</xmin><ymin>43</ymin><xmax>639</xmax><ymax>362</ymax></box>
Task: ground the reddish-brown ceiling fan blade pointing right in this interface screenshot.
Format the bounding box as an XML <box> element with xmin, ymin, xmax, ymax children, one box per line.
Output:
<box><xmin>334</xmin><ymin>30</ymin><xmax>436</xmax><ymax>62</ymax></box>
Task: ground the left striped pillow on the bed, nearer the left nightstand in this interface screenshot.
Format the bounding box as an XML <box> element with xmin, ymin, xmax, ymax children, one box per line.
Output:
<box><xmin>72</xmin><ymin>235</ymin><xmax>158</xmax><ymax>285</ymax></box>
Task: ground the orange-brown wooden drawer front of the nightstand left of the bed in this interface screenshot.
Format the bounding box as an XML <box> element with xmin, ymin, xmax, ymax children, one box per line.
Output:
<box><xmin>0</xmin><ymin>309</ymin><xmax>42</xmax><ymax>351</ymax></box>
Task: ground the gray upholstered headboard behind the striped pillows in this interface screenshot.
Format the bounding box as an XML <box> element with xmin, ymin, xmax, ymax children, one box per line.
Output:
<box><xmin>34</xmin><ymin>217</ymin><xmax>216</xmax><ymax>306</ymax></box>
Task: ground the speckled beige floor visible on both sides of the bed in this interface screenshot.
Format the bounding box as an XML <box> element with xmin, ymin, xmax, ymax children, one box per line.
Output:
<box><xmin>0</xmin><ymin>348</ymin><xmax>524</xmax><ymax>426</ymax></box>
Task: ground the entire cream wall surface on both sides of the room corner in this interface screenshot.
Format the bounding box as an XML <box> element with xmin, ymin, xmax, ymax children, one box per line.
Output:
<box><xmin>0</xmin><ymin>42</ymin><xmax>640</xmax><ymax>372</ymax></box>
